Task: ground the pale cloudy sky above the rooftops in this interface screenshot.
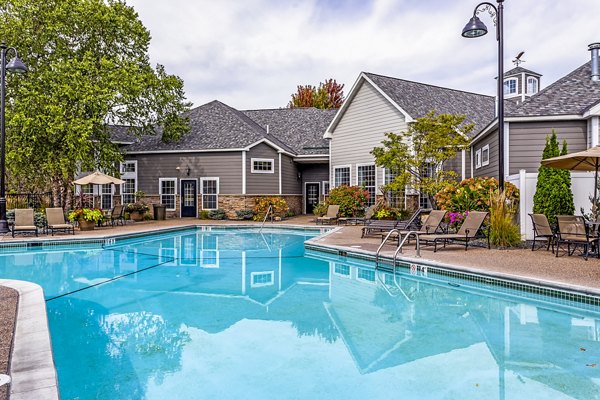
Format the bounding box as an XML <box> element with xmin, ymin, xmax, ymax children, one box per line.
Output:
<box><xmin>127</xmin><ymin>0</ymin><xmax>600</xmax><ymax>110</ymax></box>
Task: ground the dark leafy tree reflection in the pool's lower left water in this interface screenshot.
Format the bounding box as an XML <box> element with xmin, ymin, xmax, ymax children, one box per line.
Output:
<box><xmin>47</xmin><ymin>298</ymin><xmax>189</xmax><ymax>400</ymax></box>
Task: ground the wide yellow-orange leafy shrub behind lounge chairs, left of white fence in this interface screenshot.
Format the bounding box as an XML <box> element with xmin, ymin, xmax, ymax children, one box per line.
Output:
<box><xmin>435</xmin><ymin>177</ymin><xmax>519</xmax><ymax>213</ymax></box>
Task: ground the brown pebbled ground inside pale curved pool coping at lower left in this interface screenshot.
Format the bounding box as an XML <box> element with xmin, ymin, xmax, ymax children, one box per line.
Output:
<box><xmin>0</xmin><ymin>286</ymin><xmax>19</xmax><ymax>400</ymax></box>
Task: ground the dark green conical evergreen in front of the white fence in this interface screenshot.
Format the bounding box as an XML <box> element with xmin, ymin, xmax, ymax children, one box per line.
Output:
<box><xmin>533</xmin><ymin>129</ymin><xmax>575</xmax><ymax>224</ymax></box>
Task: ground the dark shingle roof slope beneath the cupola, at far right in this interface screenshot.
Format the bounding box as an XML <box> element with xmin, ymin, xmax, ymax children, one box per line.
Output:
<box><xmin>506</xmin><ymin>61</ymin><xmax>600</xmax><ymax>117</ymax></box>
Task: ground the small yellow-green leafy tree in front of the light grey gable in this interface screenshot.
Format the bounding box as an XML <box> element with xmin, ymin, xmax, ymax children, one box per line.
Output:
<box><xmin>371</xmin><ymin>111</ymin><xmax>473</xmax><ymax>208</ymax></box>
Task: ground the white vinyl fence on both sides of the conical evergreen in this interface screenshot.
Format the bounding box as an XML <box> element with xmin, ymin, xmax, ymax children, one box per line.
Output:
<box><xmin>506</xmin><ymin>169</ymin><xmax>594</xmax><ymax>240</ymax></box>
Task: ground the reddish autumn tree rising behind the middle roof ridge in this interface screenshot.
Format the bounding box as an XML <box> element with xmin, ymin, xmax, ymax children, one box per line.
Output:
<box><xmin>288</xmin><ymin>79</ymin><xmax>344</xmax><ymax>109</ymax></box>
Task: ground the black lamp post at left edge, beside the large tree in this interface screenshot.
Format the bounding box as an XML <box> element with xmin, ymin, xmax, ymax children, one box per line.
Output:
<box><xmin>0</xmin><ymin>41</ymin><xmax>27</xmax><ymax>234</ymax></box>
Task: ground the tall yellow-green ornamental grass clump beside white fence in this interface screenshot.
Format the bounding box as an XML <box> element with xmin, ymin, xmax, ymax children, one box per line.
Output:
<box><xmin>489</xmin><ymin>192</ymin><xmax>521</xmax><ymax>247</ymax></box>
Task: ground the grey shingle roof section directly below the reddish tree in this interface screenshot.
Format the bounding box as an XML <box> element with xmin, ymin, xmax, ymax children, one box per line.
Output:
<box><xmin>242</xmin><ymin>107</ymin><xmax>337</xmax><ymax>155</ymax></box>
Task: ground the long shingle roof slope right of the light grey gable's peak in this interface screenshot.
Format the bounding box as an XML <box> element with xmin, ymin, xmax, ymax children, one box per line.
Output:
<box><xmin>365</xmin><ymin>73</ymin><xmax>495</xmax><ymax>135</ymax></box>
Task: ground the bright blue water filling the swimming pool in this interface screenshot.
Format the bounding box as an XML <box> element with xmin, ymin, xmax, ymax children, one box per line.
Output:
<box><xmin>0</xmin><ymin>229</ymin><xmax>600</xmax><ymax>400</ymax></box>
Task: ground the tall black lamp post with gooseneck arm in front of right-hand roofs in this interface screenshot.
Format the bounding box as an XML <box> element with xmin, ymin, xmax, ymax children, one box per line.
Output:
<box><xmin>462</xmin><ymin>0</ymin><xmax>504</xmax><ymax>191</ymax></box>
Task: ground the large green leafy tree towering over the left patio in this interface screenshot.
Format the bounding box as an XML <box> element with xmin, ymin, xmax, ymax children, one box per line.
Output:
<box><xmin>0</xmin><ymin>0</ymin><xmax>189</xmax><ymax>207</ymax></box>
